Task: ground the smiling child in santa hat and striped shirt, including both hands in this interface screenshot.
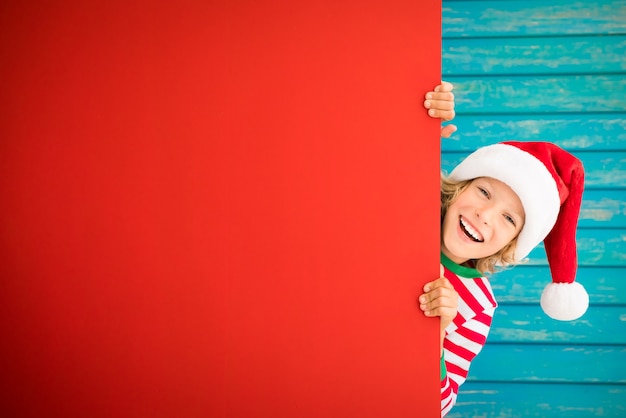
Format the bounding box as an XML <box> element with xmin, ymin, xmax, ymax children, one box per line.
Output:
<box><xmin>419</xmin><ymin>83</ymin><xmax>589</xmax><ymax>416</ymax></box>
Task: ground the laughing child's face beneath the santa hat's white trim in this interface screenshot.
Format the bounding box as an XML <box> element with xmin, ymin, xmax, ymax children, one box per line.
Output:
<box><xmin>441</xmin><ymin>177</ymin><xmax>525</xmax><ymax>264</ymax></box>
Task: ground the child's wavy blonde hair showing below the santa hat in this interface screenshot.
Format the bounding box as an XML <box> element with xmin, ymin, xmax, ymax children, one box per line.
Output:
<box><xmin>440</xmin><ymin>173</ymin><xmax>519</xmax><ymax>274</ymax></box>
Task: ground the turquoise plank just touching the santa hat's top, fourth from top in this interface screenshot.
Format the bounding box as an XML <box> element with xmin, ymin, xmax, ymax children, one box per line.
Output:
<box><xmin>441</xmin><ymin>114</ymin><xmax>626</xmax><ymax>152</ymax></box>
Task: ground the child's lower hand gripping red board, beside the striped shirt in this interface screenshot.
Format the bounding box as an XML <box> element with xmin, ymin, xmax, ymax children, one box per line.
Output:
<box><xmin>419</xmin><ymin>266</ymin><xmax>459</xmax><ymax>330</ymax></box>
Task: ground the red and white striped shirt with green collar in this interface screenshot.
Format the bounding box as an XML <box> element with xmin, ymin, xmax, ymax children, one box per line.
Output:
<box><xmin>441</xmin><ymin>254</ymin><xmax>497</xmax><ymax>417</ymax></box>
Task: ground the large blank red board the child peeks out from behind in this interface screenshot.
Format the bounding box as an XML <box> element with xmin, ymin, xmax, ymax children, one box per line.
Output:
<box><xmin>0</xmin><ymin>0</ymin><xmax>440</xmax><ymax>418</ymax></box>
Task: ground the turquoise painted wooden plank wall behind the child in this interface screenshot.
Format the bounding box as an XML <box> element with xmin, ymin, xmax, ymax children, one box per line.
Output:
<box><xmin>442</xmin><ymin>0</ymin><xmax>626</xmax><ymax>418</ymax></box>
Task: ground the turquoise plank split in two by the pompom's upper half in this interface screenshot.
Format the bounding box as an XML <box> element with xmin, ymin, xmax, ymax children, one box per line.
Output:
<box><xmin>489</xmin><ymin>265</ymin><xmax>626</xmax><ymax>305</ymax></box>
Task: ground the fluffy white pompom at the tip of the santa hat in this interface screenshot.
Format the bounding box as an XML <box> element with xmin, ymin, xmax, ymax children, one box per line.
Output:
<box><xmin>541</xmin><ymin>282</ymin><xmax>589</xmax><ymax>321</ymax></box>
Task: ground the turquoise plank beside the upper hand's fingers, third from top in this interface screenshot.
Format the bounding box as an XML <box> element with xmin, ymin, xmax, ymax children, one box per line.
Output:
<box><xmin>447</xmin><ymin>74</ymin><xmax>626</xmax><ymax>115</ymax></box>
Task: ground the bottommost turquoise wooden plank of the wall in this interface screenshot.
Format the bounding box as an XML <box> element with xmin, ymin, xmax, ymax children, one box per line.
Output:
<box><xmin>447</xmin><ymin>382</ymin><xmax>626</xmax><ymax>418</ymax></box>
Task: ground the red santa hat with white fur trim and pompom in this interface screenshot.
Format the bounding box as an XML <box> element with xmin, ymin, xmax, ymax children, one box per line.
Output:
<box><xmin>449</xmin><ymin>141</ymin><xmax>589</xmax><ymax>321</ymax></box>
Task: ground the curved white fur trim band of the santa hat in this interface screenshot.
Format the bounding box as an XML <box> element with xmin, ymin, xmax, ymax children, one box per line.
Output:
<box><xmin>449</xmin><ymin>143</ymin><xmax>561</xmax><ymax>261</ymax></box>
